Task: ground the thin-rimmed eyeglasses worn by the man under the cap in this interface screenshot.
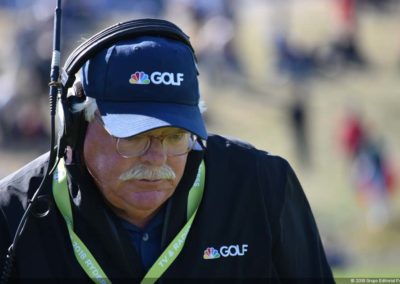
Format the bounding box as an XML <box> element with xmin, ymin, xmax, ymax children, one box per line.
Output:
<box><xmin>95</xmin><ymin>115</ymin><xmax>197</xmax><ymax>158</ymax></box>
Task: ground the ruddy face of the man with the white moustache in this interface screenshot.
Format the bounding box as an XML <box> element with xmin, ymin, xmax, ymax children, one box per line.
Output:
<box><xmin>83</xmin><ymin>120</ymin><xmax>187</xmax><ymax>226</ymax></box>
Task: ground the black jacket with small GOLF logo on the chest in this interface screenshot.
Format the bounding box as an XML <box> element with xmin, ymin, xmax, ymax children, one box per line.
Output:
<box><xmin>0</xmin><ymin>136</ymin><xmax>333</xmax><ymax>283</ymax></box>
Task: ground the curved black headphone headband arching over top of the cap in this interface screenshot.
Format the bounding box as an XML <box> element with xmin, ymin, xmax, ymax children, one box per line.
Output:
<box><xmin>61</xmin><ymin>19</ymin><xmax>194</xmax><ymax>89</ymax></box>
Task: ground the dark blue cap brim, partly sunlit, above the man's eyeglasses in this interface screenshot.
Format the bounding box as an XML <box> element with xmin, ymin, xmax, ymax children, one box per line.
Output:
<box><xmin>97</xmin><ymin>101</ymin><xmax>207</xmax><ymax>139</ymax></box>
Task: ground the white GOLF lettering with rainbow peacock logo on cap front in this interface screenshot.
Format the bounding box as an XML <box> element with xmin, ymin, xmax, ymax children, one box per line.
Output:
<box><xmin>129</xmin><ymin>71</ymin><xmax>183</xmax><ymax>86</ymax></box>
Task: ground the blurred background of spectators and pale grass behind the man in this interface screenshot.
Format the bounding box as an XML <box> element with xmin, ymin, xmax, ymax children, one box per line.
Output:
<box><xmin>0</xmin><ymin>0</ymin><xmax>400</xmax><ymax>279</ymax></box>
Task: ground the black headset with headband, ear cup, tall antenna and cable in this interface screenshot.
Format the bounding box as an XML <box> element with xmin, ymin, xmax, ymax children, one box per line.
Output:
<box><xmin>0</xmin><ymin>16</ymin><xmax>197</xmax><ymax>284</ymax></box>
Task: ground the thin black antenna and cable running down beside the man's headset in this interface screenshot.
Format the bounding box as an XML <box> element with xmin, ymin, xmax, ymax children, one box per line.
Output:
<box><xmin>0</xmin><ymin>0</ymin><xmax>62</xmax><ymax>284</ymax></box>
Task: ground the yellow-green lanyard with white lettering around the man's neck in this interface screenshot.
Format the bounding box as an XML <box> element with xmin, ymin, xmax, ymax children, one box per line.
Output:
<box><xmin>53</xmin><ymin>159</ymin><xmax>205</xmax><ymax>284</ymax></box>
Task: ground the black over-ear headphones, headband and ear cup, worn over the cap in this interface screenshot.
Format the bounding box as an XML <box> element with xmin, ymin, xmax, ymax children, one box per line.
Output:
<box><xmin>58</xmin><ymin>19</ymin><xmax>196</xmax><ymax>156</ymax></box>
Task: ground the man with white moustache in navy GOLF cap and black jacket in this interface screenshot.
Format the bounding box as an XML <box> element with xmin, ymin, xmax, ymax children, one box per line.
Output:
<box><xmin>0</xmin><ymin>18</ymin><xmax>333</xmax><ymax>283</ymax></box>
